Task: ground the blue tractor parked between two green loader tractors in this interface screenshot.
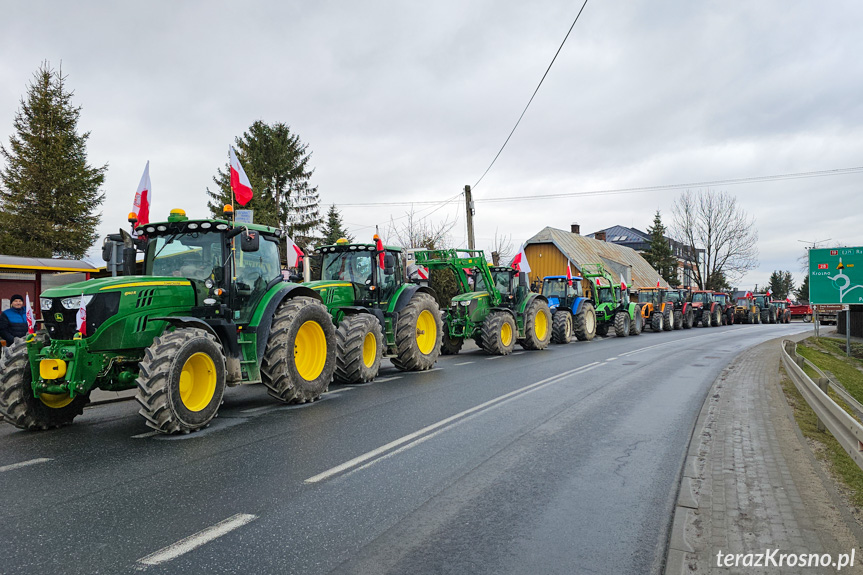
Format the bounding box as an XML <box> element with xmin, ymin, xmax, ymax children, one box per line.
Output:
<box><xmin>542</xmin><ymin>276</ymin><xmax>596</xmax><ymax>343</ymax></box>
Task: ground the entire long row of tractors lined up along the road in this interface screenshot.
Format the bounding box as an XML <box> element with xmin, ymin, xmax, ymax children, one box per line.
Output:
<box><xmin>0</xmin><ymin>206</ymin><xmax>780</xmax><ymax>433</ymax></box>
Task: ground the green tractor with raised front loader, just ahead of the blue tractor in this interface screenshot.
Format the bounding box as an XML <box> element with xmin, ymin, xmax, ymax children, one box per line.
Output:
<box><xmin>414</xmin><ymin>249</ymin><xmax>551</xmax><ymax>355</ymax></box>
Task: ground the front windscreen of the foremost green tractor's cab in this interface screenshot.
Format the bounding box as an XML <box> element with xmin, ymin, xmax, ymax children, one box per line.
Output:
<box><xmin>144</xmin><ymin>233</ymin><xmax>223</xmax><ymax>281</ymax></box>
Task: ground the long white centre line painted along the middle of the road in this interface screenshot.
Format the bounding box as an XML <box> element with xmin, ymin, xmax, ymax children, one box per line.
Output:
<box><xmin>304</xmin><ymin>361</ymin><xmax>599</xmax><ymax>483</ymax></box>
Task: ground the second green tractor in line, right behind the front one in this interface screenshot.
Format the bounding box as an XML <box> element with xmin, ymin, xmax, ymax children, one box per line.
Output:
<box><xmin>304</xmin><ymin>236</ymin><xmax>441</xmax><ymax>383</ymax></box>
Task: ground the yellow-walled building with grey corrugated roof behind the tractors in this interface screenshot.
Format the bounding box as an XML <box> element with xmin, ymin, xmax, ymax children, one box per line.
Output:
<box><xmin>524</xmin><ymin>224</ymin><xmax>670</xmax><ymax>289</ymax></box>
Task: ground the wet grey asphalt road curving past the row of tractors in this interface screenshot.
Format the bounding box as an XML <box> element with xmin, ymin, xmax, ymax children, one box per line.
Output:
<box><xmin>0</xmin><ymin>323</ymin><xmax>811</xmax><ymax>575</ymax></box>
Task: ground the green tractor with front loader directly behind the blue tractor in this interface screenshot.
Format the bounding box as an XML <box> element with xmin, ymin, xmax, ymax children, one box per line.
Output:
<box><xmin>581</xmin><ymin>264</ymin><xmax>644</xmax><ymax>337</ymax></box>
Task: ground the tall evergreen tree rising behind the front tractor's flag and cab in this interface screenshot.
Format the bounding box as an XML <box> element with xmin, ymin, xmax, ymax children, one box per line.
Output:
<box><xmin>207</xmin><ymin>120</ymin><xmax>320</xmax><ymax>251</ymax></box>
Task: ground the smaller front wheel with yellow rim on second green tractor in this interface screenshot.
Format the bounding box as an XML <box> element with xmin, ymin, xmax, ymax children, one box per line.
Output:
<box><xmin>334</xmin><ymin>313</ymin><xmax>384</xmax><ymax>383</ymax></box>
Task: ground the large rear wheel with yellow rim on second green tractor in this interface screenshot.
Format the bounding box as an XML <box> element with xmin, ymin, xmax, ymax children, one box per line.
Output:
<box><xmin>390</xmin><ymin>292</ymin><xmax>443</xmax><ymax>371</ymax></box>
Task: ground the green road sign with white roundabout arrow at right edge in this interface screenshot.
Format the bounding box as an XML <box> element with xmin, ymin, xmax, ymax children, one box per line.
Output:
<box><xmin>809</xmin><ymin>248</ymin><xmax>863</xmax><ymax>304</ymax></box>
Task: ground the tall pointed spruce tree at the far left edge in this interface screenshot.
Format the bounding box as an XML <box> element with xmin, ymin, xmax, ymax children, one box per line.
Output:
<box><xmin>0</xmin><ymin>62</ymin><xmax>108</xmax><ymax>258</ymax></box>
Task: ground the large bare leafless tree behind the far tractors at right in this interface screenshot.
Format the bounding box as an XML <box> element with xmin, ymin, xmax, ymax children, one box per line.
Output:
<box><xmin>673</xmin><ymin>190</ymin><xmax>758</xmax><ymax>289</ymax></box>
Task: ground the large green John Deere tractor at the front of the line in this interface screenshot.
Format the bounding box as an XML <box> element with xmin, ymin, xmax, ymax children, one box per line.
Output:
<box><xmin>0</xmin><ymin>210</ymin><xmax>335</xmax><ymax>433</ymax></box>
